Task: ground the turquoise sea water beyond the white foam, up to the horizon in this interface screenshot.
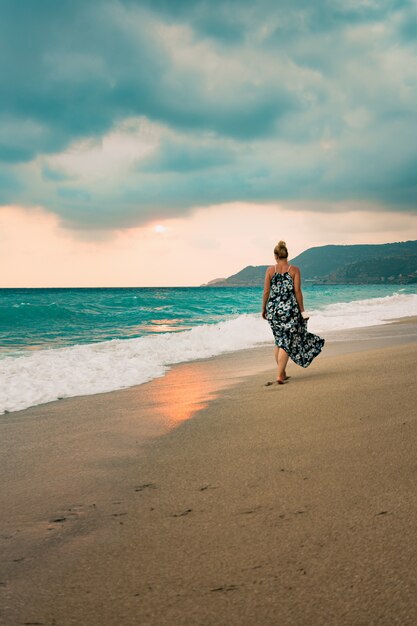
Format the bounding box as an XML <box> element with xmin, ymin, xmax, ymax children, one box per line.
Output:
<box><xmin>0</xmin><ymin>285</ymin><xmax>417</xmax><ymax>357</ymax></box>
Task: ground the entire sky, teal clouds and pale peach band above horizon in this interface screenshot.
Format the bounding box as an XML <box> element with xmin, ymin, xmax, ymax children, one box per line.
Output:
<box><xmin>0</xmin><ymin>0</ymin><xmax>417</xmax><ymax>287</ymax></box>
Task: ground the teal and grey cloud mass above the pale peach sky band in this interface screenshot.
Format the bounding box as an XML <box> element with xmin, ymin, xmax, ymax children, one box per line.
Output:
<box><xmin>0</xmin><ymin>0</ymin><xmax>417</xmax><ymax>231</ymax></box>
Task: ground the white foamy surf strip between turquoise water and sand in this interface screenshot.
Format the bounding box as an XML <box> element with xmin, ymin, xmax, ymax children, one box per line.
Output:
<box><xmin>0</xmin><ymin>293</ymin><xmax>417</xmax><ymax>414</ymax></box>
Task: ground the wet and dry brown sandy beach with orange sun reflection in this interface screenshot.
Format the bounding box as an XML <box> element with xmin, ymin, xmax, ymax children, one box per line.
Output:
<box><xmin>0</xmin><ymin>319</ymin><xmax>417</xmax><ymax>626</ymax></box>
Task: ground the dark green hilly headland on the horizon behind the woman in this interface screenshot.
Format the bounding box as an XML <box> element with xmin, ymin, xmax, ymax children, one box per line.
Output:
<box><xmin>201</xmin><ymin>241</ymin><xmax>417</xmax><ymax>287</ymax></box>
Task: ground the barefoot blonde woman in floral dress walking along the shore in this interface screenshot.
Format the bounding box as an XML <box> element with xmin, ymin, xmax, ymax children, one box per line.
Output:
<box><xmin>262</xmin><ymin>241</ymin><xmax>324</xmax><ymax>385</ymax></box>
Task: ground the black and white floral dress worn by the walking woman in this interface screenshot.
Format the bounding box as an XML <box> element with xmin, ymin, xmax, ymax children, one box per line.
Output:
<box><xmin>266</xmin><ymin>272</ymin><xmax>324</xmax><ymax>367</ymax></box>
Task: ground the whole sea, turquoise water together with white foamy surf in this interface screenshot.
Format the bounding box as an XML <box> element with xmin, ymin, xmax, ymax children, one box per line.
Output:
<box><xmin>0</xmin><ymin>284</ymin><xmax>417</xmax><ymax>414</ymax></box>
